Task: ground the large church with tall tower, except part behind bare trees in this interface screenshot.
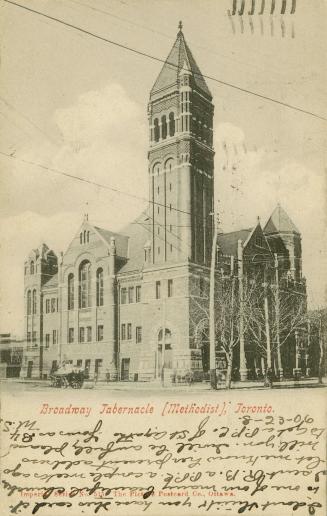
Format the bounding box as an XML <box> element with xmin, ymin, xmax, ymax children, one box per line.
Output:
<box><xmin>21</xmin><ymin>26</ymin><xmax>304</xmax><ymax>381</ymax></box>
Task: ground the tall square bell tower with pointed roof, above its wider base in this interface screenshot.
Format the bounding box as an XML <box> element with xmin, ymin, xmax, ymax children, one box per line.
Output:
<box><xmin>148</xmin><ymin>22</ymin><xmax>214</xmax><ymax>265</ymax></box>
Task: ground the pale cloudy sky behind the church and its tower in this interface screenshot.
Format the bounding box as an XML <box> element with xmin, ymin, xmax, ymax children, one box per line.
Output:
<box><xmin>0</xmin><ymin>0</ymin><xmax>327</xmax><ymax>335</ymax></box>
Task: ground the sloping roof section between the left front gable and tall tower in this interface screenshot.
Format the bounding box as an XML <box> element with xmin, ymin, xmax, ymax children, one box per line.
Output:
<box><xmin>119</xmin><ymin>211</ymin><xmax>151</xmax><ymax>274</ymax></box>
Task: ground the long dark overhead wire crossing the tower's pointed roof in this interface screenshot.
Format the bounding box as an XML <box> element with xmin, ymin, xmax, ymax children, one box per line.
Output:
<box><xmin>2</xmin><ymin>0</ymin><xmax>327</xmax><ymax>120</ymax></box>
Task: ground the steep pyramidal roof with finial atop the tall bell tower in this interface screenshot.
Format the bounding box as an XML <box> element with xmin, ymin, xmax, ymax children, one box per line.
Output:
<box><xmin>150</xmin><ymin>22</ymin><xmax>212</xmax><ymax>100</ymax></box>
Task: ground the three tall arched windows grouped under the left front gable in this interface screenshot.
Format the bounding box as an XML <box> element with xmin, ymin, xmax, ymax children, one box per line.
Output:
<box><xmin>67</xmin><ymin>260</ymin><xmax>104</xmax><ymax>310</ymax></box>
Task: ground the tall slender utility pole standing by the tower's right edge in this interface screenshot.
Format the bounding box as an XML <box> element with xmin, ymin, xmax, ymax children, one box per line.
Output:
<box><xmin>209</xmin><ymin>213</ymin><xmax>218</xmax><ymax>389</ymax></box>
